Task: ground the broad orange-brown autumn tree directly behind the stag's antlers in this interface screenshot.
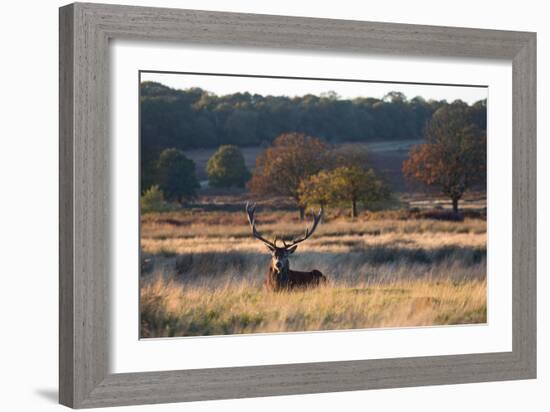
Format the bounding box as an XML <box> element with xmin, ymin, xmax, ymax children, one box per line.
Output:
<box><xmin>249</xmin><ymin>133</ymin><xmax>328</xmax><ymax>219</ymax></box>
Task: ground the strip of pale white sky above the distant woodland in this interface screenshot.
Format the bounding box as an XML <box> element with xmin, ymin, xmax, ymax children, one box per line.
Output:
<box><xmin>141</xmin><ymin>72</ymin><xmax>488</xmax><ymax>104</ymax></box>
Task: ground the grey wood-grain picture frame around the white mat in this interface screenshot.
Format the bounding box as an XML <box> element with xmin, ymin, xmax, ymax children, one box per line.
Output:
<box><xmin>59</xmin><ymin>3</ymin><xmax>536</xmax><ymax>408</ymax></box>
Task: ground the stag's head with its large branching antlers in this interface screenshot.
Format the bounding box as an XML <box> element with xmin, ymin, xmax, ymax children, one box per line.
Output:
<box><xmin>246</xmin><ymin>203</ymin><xmax>323</xmax><ymax>273</ymax></box>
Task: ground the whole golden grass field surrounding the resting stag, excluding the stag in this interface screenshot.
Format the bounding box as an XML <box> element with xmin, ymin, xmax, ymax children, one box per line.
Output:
<box><xmin>140</xmin><ymin>196</ymin><xmax>486</xmax><ymax>337</ymax></box>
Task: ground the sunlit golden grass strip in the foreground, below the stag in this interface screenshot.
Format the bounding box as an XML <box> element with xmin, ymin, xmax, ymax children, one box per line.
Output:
<box><xmin>141</xmin><ymin>276</ymin><xmax>487</xmax><ymax>337</ymax></box>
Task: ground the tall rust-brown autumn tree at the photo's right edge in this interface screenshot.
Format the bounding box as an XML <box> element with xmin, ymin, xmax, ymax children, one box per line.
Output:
<box><xmin>403</xmin><ymin>102</ymin><xmax>487</xmax><ymax>213</ymax></box>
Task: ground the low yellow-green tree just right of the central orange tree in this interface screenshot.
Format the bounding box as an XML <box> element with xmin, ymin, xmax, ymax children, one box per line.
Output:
<box><xmin>329</xmin><ymin>165</ymin><xmax>390</xmax><ymax>218</ymax></box>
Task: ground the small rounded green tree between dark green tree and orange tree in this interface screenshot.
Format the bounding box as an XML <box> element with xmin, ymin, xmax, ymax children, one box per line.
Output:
<box><xmin>206</xmin><ymin>145</ymin><xmax>250</xmax><ymax>187</ymax></box>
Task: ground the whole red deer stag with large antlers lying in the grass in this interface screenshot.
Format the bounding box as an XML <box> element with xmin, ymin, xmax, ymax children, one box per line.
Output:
<box><xmin>246</xmin><ymin>203</ymin><xmax>327</xmax><ymax>291</ymax></box>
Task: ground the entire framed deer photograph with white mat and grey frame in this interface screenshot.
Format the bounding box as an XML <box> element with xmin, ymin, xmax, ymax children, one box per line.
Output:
<box><xmin>60</xmin><ymin>3</ymin><xmax>536</xmax><ymax>408</ymax></box>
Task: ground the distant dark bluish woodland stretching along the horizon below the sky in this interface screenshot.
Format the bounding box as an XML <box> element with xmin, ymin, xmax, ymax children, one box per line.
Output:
<box><xmin>140</xmin><ymin>82</ymin><xmax>485</xmax><ymax>174</ymax></box>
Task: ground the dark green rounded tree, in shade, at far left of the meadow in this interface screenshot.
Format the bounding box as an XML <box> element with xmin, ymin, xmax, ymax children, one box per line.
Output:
<box><xmin>157</xmin><ymin>148</ymin><xmax>200</xmax><ymax>203</ymax></box>
